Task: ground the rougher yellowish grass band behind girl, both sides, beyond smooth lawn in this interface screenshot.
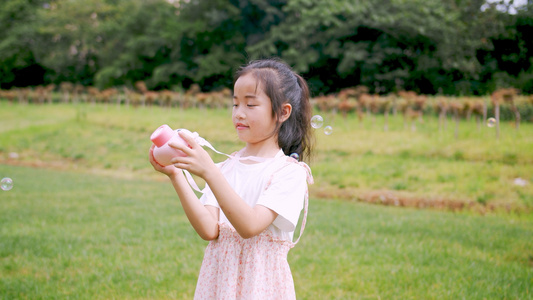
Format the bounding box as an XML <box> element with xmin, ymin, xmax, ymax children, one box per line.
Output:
<box><xmin>0</xmin><ymin>101</ymin><xmax>533</xmax><ymax>210</ymax></box>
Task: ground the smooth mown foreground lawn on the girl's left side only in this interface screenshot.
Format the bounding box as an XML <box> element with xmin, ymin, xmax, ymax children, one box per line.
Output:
<box><xmin>0</xmin><ymin>166</ymin><xmax>201</xmax><ymax>299</ymax></box>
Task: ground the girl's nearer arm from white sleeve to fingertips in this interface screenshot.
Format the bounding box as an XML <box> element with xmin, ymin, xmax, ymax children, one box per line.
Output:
<box><xmin>169</xmin><ymin>132</ymin><xmax>278</xmax><ymax>239</ymax></box>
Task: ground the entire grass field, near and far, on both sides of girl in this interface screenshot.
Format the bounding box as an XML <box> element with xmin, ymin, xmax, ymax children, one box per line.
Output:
<box><xmin>0</xmin><ymin>101</ymin><xmax>533</xmax><ymax>299</ymax></box>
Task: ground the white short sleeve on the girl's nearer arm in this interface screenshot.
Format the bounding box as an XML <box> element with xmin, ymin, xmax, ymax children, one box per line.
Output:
<box><xmin>257</xmin><ymin>163</ymin><xmax>307</xmax><ymax>232</ymax></box>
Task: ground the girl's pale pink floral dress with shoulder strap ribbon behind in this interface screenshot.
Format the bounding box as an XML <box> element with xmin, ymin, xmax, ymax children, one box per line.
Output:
<box><xmin>194</xmin><ymin>155</ymin><xmax>312</xmax><ymax>299</ymax></box>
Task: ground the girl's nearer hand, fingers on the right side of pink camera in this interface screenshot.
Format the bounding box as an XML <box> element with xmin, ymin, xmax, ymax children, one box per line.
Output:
<box><xmin>168</xmin><ymin>131</ymin><xmax>217</xmax><ymax>179</ymax></box>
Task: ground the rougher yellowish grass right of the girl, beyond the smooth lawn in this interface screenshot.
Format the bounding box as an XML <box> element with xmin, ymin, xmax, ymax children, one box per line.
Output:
<box><xmin>313</xmin><ymin>110</ymin><xmax>533</xmax><ymax>207</ymax></box>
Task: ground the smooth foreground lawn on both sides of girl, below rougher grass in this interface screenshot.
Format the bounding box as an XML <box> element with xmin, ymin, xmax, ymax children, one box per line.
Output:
<box><xmin>0</xmin><ymin>165</ymin><xmax>533</xmax><ymax>299</ymax></box>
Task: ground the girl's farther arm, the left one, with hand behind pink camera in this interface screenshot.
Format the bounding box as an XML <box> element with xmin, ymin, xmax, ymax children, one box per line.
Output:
<box><xmin>150</xmin><ymin>145</ymin><xmax>219</xmax><ymax>241</ymax></box>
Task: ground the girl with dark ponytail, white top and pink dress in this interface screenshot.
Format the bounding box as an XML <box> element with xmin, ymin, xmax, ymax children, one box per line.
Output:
<box><xmin>150</xmin><ymin>59</ymin><xmax>312</xmax><ymax>299</ymax></box>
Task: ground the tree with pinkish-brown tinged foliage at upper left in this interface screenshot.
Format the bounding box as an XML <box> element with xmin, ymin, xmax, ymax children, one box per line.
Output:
<box><xmin>32</xmin><ymin>0</ymin><xmax>122</xmax><ymax>85</ymax></box>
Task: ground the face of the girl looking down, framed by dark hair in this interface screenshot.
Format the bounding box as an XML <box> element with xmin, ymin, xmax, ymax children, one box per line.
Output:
<box><xmin>232</xmin><ymin>73</ymin><xmax>277</xmax><ymax>150</ymax></box>
